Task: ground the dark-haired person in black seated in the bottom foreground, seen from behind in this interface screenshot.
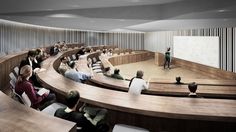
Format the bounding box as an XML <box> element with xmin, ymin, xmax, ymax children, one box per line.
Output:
<box><xmin>54</xmin><ymin>90</ymin><xmax>109</xmax><ymax>132</ymax></box>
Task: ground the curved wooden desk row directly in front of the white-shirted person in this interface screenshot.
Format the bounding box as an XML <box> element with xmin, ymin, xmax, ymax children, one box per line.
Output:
<box><xmin>90</xmin><ymin>74</ymin><xmax>236</xmax><ymax>99</ymax></box>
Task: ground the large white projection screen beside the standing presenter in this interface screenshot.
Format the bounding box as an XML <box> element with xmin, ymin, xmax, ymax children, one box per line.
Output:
<box><xmin>173</xmin><ymin>36</ymin><xmax>219</xmax><ymax>68</ymax></box>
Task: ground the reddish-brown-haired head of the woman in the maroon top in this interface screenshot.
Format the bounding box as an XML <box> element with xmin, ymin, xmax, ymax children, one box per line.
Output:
<box><xmin>18</xmin><ymin>65</ymin><xmax>32</xmax><ymax>82</ymax></box>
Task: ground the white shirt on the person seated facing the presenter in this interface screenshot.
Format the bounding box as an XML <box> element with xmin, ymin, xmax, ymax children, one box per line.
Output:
<box><xmin>128</xmin><ymin>78</ymin><xmax>148</xmax><ymax>95</ymax></box>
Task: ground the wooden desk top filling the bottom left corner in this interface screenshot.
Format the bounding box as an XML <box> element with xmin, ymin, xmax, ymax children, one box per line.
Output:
<box><xmin>0</xmin><ymin>91</ymin><xmax>76</xmax><ymax>132</ymax></box>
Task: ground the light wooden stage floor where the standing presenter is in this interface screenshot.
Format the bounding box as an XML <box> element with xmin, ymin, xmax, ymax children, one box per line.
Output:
<box><xmin>115</xmin><ymin>59</ymin><xmax>214</xmax><ymax>80</ymax></box>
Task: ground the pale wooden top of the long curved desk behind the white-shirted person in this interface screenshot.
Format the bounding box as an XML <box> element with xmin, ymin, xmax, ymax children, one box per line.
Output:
<box><xmin>38</xmin><ymin>53</ymin><xmax>236</xmax><ymax>122</ymax></box>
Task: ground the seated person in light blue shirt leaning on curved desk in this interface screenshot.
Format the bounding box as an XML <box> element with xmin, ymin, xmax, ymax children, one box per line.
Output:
<box><xmin>65</xmin><ymin>61</ymin><xmax>92</xmax><ymax>82</ymax></box>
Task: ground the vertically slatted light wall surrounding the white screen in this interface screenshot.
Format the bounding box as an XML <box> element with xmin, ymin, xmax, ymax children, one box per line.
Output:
<box><xmin>144</xmin><ymin>27</ymin><xmax>236</xmax><ymax>72</ymax></box>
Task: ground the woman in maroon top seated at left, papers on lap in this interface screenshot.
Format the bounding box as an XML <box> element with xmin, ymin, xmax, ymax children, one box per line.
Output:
<box><xmin>15</xmin><ymin>65</ymin><xmax>56</xmax><ymax>110</ymax></box>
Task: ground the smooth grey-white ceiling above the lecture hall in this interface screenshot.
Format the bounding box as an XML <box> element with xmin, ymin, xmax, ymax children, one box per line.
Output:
<box><xmin>0</xmin><ymin>0</ymin><xmax>236</xmax><ymax>32</ymax></box>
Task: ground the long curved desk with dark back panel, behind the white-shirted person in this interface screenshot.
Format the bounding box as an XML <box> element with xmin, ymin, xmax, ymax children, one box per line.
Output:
<box><xmin>38</xmin><ymin>50</ymin><xmax>236</xmax><ymax>131</ymax></box>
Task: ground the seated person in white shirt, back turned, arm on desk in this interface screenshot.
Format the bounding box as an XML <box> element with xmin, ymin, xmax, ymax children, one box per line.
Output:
<box><xmin>128</xmin><ymin>71</ymin><xmax>149</xmax><ymax>95</ymax></box>
